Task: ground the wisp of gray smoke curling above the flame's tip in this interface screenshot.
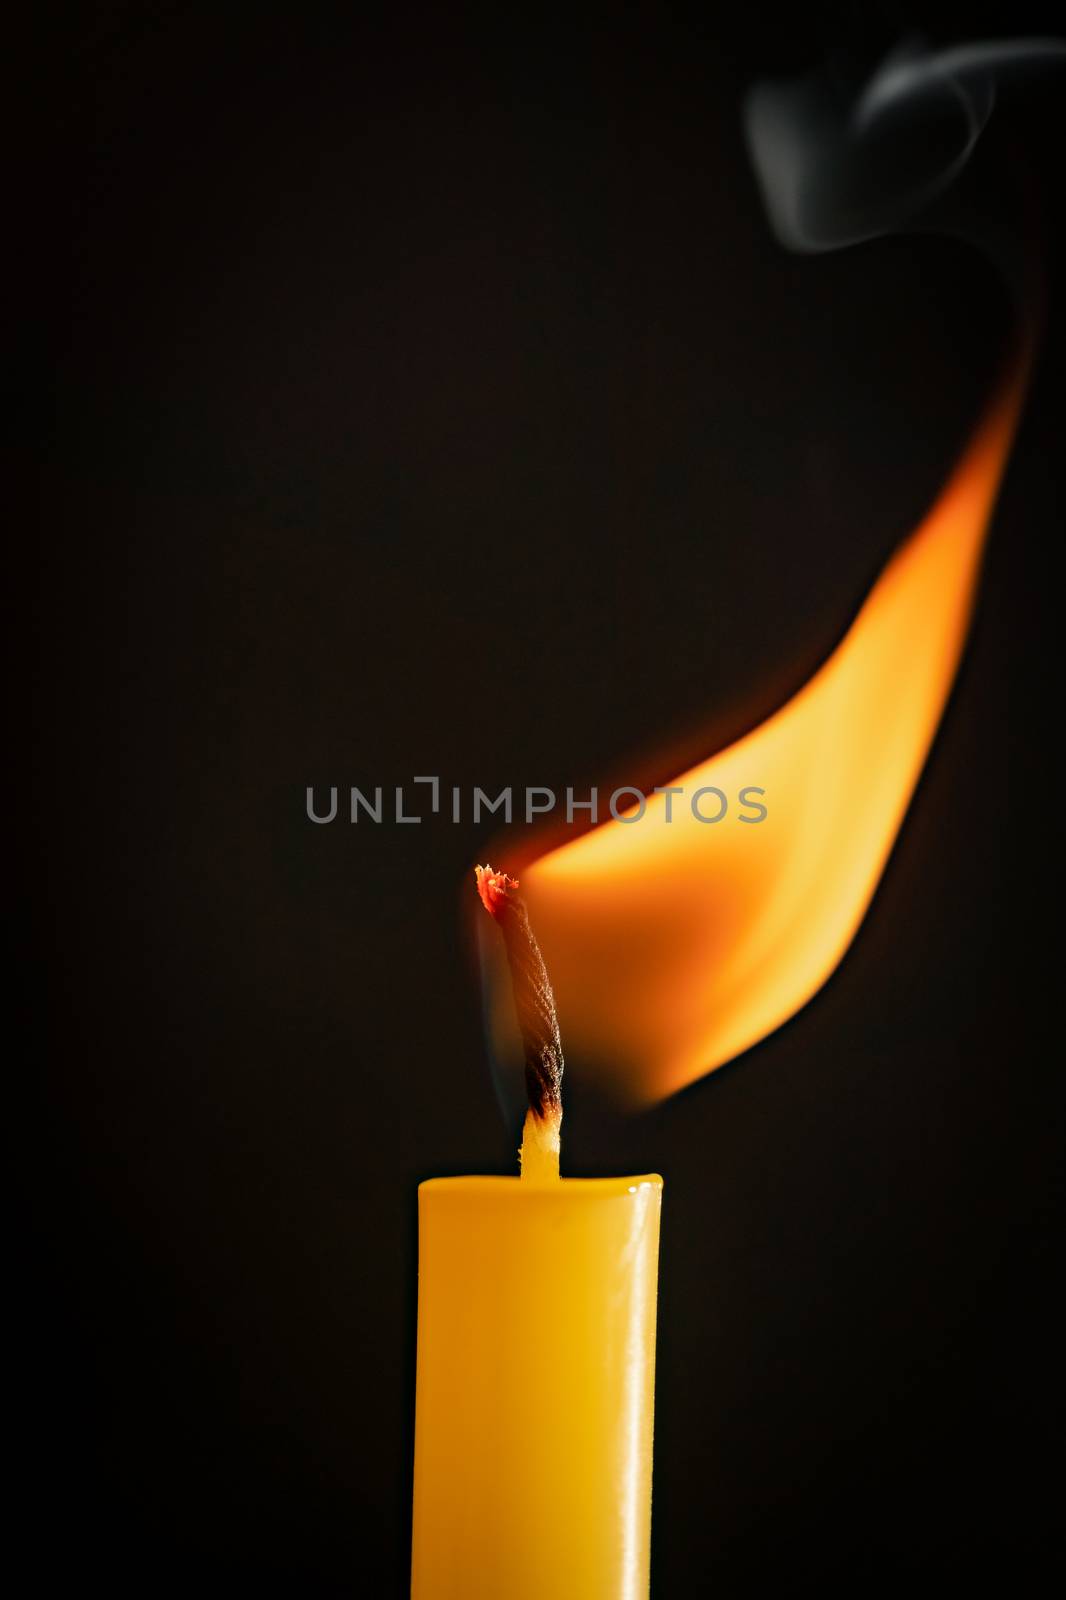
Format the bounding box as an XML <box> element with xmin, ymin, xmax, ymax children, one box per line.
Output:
<box><xmin>743</xmin><ymin>38</ymin><xmax>1066</xmax><ymax>251</ymax></box>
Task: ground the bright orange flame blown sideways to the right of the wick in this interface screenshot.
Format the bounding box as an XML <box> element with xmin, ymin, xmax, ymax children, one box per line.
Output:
<box><xmin>490</xmin><ymin>352</ymin><xmax>1028</xmax><ymax>1104</ymax></box>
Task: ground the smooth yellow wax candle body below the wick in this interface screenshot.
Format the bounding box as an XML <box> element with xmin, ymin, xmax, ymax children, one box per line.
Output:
<box><xmin>411</xmin><ymin>1176</ymin><xmax>663</xmax><ymax>1600</ymax></box>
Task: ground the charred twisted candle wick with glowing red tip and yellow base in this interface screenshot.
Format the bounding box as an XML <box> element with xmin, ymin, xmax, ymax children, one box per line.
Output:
<box><xmin>474</xmin><ymin>866</ymin><xmax>563</xmax><ymax>1179</ymax></box>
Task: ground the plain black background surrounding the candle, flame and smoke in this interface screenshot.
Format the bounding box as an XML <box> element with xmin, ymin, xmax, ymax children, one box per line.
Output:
<box><xmin>37</xmin><ymin>5</ymin><xmax>1063</xmax><ymax>1597</ymax></box>
